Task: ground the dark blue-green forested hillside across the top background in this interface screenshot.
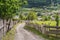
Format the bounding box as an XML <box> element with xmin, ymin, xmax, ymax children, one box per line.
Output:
<box><xmin>24</xmin><ymin>0</ymin><xmax>60</xmax><ymax>7</ymax></box>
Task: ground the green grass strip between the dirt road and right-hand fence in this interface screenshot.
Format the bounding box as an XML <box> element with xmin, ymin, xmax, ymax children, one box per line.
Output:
<box><xmin>24</xmin><ymin>26</ymin><xmax>60</xmax><ymax>40</ymax></box>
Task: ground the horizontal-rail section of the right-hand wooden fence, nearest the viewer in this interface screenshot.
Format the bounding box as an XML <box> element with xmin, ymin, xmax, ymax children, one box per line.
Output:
<box><xmin>44</xmin><ymin>26</ymin><xmax>60</xmax><ymax>38</ymax></box>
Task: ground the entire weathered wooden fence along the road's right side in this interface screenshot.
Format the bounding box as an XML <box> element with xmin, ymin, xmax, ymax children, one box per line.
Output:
<box><xmin>26</xmin><ymin>22</ymin><xmax>60</xmax><ymax>38</ymax></box>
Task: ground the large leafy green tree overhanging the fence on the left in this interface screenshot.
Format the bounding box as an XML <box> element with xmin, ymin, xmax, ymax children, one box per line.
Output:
<box><xmin>0</xmin><ymin>0</ymin><xmax>26</xmax><ymax>30</ymax></box>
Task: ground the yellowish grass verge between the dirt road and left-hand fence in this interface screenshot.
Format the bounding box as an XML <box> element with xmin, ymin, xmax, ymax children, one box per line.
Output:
<box><xmin>2</xmin><ymin>23</ymin><xmax>19</xmax><ymax>40</ymax></box>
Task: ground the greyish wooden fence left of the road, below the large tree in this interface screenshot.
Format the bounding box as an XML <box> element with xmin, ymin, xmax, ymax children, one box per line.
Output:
<box><xmin>0</xmin><ymin>19</ymin><xmax>18</xmax><ymax>40</ymax></box>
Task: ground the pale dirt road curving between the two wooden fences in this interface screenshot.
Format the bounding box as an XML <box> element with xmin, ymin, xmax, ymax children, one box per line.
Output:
<box><xmin>15</xmin><ymin>23</ymin><xmax>44</xmax><ymax>40</ymax></box>
